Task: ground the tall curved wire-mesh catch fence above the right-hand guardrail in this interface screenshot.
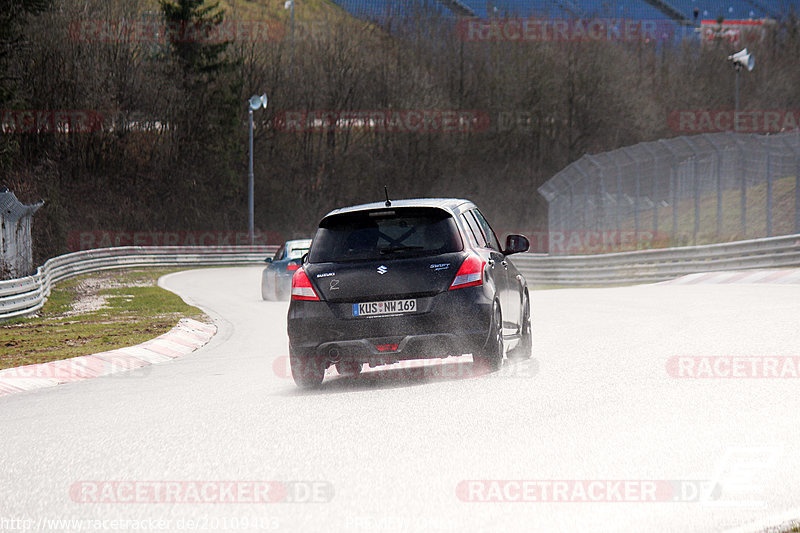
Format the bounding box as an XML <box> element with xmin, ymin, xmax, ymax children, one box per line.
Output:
<box><xmin>539</xmin><ymin>130</ymin><xmax>800</xmax><ymax>253</ymax></box>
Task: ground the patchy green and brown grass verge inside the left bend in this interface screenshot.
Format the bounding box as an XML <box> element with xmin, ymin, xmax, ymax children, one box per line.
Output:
<box><xmin>0</xmin><ymin>269</ymin><xmax>207</xmax><ymax>369</ymax></box>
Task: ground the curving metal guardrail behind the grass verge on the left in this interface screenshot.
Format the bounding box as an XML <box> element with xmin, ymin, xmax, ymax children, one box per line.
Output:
<box><xmin>0</xmin><ymin>246</ymin><xmax>278</xmax><ymax>320</ymax></box>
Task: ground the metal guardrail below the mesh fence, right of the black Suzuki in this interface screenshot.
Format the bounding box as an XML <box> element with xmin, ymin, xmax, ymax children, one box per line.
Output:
<box><xmin>512</xmin><ymin>234</ymin><xmax>800</xmax><ymax>286</ymax></box>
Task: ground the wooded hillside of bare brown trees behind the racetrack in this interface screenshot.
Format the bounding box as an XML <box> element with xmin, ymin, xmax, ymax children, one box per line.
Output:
<box><xmin>0</xmin><ymin>0</ymin><xmax>800</xmax><ymax>263</ymax></box>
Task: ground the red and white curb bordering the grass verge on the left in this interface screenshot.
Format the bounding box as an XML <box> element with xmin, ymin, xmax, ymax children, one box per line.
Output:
<box><xmin>0</xmin><ymin>318</ymin><xmax>217</xmax><ymax>396</ymax></box>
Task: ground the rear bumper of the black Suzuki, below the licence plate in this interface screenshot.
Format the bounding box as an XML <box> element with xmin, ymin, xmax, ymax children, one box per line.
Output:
<box><xmin>288</xmin><ymin>287</ymin><xmax>492</xmax><ymax>364</ymax></box>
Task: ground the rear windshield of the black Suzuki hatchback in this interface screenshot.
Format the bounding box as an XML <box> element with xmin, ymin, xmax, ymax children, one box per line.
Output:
<box><xmin>308</xmin><ymin>208</ymin><xmax>464</xmax><ymax>263</ymax></box>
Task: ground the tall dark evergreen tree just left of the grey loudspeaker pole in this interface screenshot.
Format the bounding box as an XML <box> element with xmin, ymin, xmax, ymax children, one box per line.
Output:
<box><xmin>160</xmin><ymin>0</ymin><xmax>243</xmax><ymax>224</ymax></box>
